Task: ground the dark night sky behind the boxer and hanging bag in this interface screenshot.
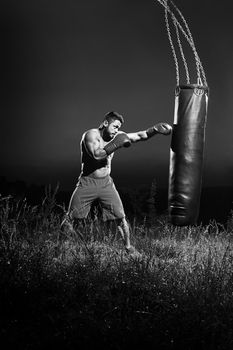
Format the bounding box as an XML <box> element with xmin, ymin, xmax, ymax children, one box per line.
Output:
<box><xmin>0</xmin><ymin>0</ymin><xmax>233</xmax><ymax>189</ymax></box>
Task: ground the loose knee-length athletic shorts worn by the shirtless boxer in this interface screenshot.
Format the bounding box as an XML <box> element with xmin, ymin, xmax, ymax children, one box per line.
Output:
<box><xmin>68</xmin><ymin>175</ymin><xmax>125</xmax><ymax>221</ymax></box>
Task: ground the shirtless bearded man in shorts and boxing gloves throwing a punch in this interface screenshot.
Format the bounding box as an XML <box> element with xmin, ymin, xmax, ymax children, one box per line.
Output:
<box><xmin>62</xmin><ymin>112</ymin><xmax>172</xmax><ymax>254</ymax></box>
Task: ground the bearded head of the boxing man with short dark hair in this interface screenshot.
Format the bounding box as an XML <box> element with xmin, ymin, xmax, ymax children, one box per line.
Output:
<box><xmin>99</xmin><ymin>112</ymin><xmax>124</xmax><ymax>141</ymax></box>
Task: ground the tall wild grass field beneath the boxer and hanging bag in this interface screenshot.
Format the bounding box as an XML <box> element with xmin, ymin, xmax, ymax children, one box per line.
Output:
<box><xmin>0</xmin><ymin>191</ymin><xmax>233</xmax><ymax>350</ymax></box>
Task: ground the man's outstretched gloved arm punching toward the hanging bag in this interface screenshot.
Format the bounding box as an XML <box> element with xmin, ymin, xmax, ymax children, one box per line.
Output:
<box><xmin>127</xmin><ymin>123</ymin><xmax>172</xmax><ymax>142</ymax></box>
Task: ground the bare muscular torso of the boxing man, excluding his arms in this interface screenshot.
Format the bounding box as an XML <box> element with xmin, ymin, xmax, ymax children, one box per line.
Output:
<box><xmin>80</xmin><ymin>129</ymin><xmax>113</xmax><ymax>178</ymax></box>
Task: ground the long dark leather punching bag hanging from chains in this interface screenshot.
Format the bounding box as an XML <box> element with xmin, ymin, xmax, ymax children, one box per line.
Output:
<box><xmin>168</xmin><ymin>84</ymin><xmax>209</xmax><ymax>226</ymax></box>
